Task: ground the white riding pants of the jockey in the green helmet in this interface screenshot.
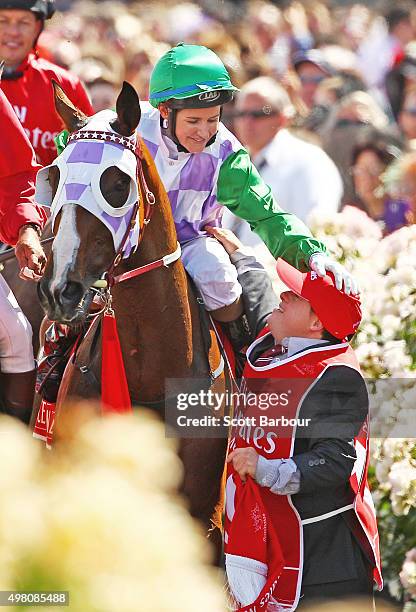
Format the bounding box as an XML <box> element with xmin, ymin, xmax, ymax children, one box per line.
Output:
<box><xmin>181</xmin><ymin>236</ymin><xmax>242</xmax><ymax>310</ymax></box>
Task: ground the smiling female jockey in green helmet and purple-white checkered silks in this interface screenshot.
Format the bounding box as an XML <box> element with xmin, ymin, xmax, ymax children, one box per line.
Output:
<box><xmin>138</xmin><ymin>43</ymin><xmax>357</xmax><ymax>334</ymax></box>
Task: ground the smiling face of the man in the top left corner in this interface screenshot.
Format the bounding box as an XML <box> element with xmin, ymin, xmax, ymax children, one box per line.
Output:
<box><xmin>0</xmin><ymin>9</ymin><xmax>42</xmax><ymax>67</ymax></box>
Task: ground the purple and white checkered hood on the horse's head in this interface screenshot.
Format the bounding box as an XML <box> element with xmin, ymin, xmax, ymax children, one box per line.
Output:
<box><xmin>35</xmin><ymin>110</ymin><xmax>139</xmax><ymax>258</ymax></box>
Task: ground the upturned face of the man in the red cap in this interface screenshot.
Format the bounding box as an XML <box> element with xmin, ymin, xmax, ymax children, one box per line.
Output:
<box><xmin>267</xmin><ymin>291</ymin><xmax>323</xmax><ymax>342</ymax></box>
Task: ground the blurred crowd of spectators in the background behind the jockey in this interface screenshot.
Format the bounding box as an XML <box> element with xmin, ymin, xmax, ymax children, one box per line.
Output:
<box><xmin>32</xmin><ymin>0</ymin><xmax>416</xmax><ymax>233</ymax></box>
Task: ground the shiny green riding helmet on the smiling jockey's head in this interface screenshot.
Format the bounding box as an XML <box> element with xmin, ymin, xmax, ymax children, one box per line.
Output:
<box><xmin>149</xmin><ymin>43</ymin><xmax>237</xmax><ymax>109</ymax></box>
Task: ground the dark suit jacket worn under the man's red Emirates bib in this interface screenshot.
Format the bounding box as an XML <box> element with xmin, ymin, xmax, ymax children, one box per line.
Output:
<box><xmin>235</xmin><ymin>255</ymin><xmax>369</xmax><ymax>585</ymax></box>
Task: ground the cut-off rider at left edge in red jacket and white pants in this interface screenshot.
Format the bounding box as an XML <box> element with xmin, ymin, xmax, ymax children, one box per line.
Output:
<box><xmin>0</xmin><ymin>85</ymin><xmax>46</xmax><ymax>423</ymax></box>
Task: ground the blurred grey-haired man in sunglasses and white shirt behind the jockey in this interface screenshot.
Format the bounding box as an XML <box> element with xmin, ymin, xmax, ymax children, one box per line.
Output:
<box><xmin>227</xmin><ymin>77</ymin><xmax>342</xmax><ymax>234</ymax></box>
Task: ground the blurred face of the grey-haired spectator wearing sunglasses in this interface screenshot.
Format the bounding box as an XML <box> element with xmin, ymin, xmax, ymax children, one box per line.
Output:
<box><xmin>235</xmin><ymin>94</ymin><xmax>282</xmax><ymax>154</ymax></box>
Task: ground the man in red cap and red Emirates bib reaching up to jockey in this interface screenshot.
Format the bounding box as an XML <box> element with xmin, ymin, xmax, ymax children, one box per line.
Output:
<box><xmin>211</xmin><ymin>228</ymin><xmax>382</xmax><ymax>611</ymax></box>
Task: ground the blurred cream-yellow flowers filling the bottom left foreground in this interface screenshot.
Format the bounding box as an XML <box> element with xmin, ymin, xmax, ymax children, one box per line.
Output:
<box><xmin>0</xmin><ymin>411</ymin><xmax>225</xmax><ymax>612</ymax></box>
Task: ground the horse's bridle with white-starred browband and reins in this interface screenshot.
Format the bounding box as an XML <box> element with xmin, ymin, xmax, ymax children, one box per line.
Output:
<box><xmin>67</xmin><ymin>130</ymin><xmax>181</xmax><ymax>292</ymax></box>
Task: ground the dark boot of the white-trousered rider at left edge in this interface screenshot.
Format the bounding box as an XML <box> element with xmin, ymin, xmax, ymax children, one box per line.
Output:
<box><xmin>0</xmin><ymin>370</ymin><xmax>36</xmax><ymax>425</ymax></box>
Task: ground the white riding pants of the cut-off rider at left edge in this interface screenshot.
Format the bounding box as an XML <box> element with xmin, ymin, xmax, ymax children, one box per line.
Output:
<box><xmin>0</xmin><ymin>274</ymin><xmax>35</xmax><ymax>374</ymax></box>
